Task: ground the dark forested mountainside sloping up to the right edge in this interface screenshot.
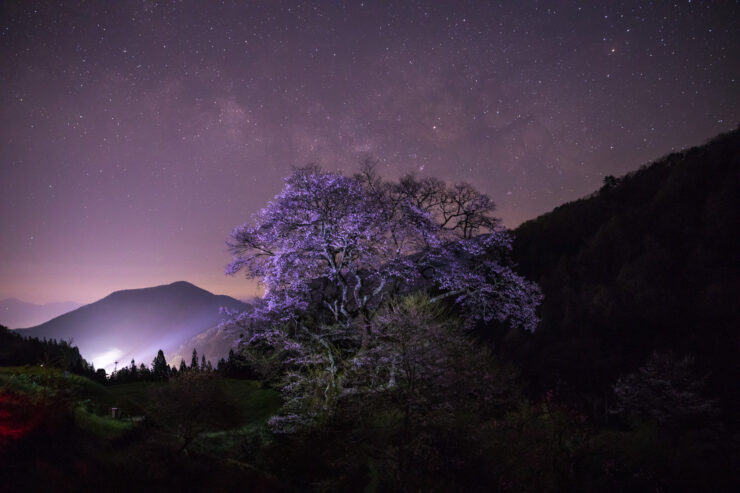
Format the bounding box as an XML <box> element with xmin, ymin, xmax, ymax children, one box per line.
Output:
<box><xmin>502</xmin><ymin>125</ymin><xmax>740</xmax><ymax>415</ymax></box>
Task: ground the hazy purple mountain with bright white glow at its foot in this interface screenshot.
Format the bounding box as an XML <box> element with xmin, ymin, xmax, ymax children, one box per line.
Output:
<box><xmin>21</xmin><ymin>281</ymin><xmax>248</xmax><ymax>370</ymax></box>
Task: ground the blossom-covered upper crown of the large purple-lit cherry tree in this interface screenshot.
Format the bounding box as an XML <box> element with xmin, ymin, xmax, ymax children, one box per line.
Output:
<box><xmin>227</xmin><ymin>165</ymin><xmax>540</xmax><ymax>330</ymax></box>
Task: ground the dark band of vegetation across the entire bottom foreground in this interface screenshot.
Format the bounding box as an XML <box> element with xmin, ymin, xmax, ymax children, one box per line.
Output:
<box><xmin>0</xmin><ymin>316</ymin><xmax>736</xmax><ymax>492</ymax></box>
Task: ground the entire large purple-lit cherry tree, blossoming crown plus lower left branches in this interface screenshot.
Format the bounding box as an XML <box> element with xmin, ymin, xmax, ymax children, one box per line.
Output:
<box><xmin>227</xmin><ymin>163</ymin><xmax>541</xmax><ymax>428</ymax></box>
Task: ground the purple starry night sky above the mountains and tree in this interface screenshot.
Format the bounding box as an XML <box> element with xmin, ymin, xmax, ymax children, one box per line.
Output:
<box><xmin>0</xmin><ymin>0</ymin><xmax>740</xmax><ymax>303</ymax></box>
